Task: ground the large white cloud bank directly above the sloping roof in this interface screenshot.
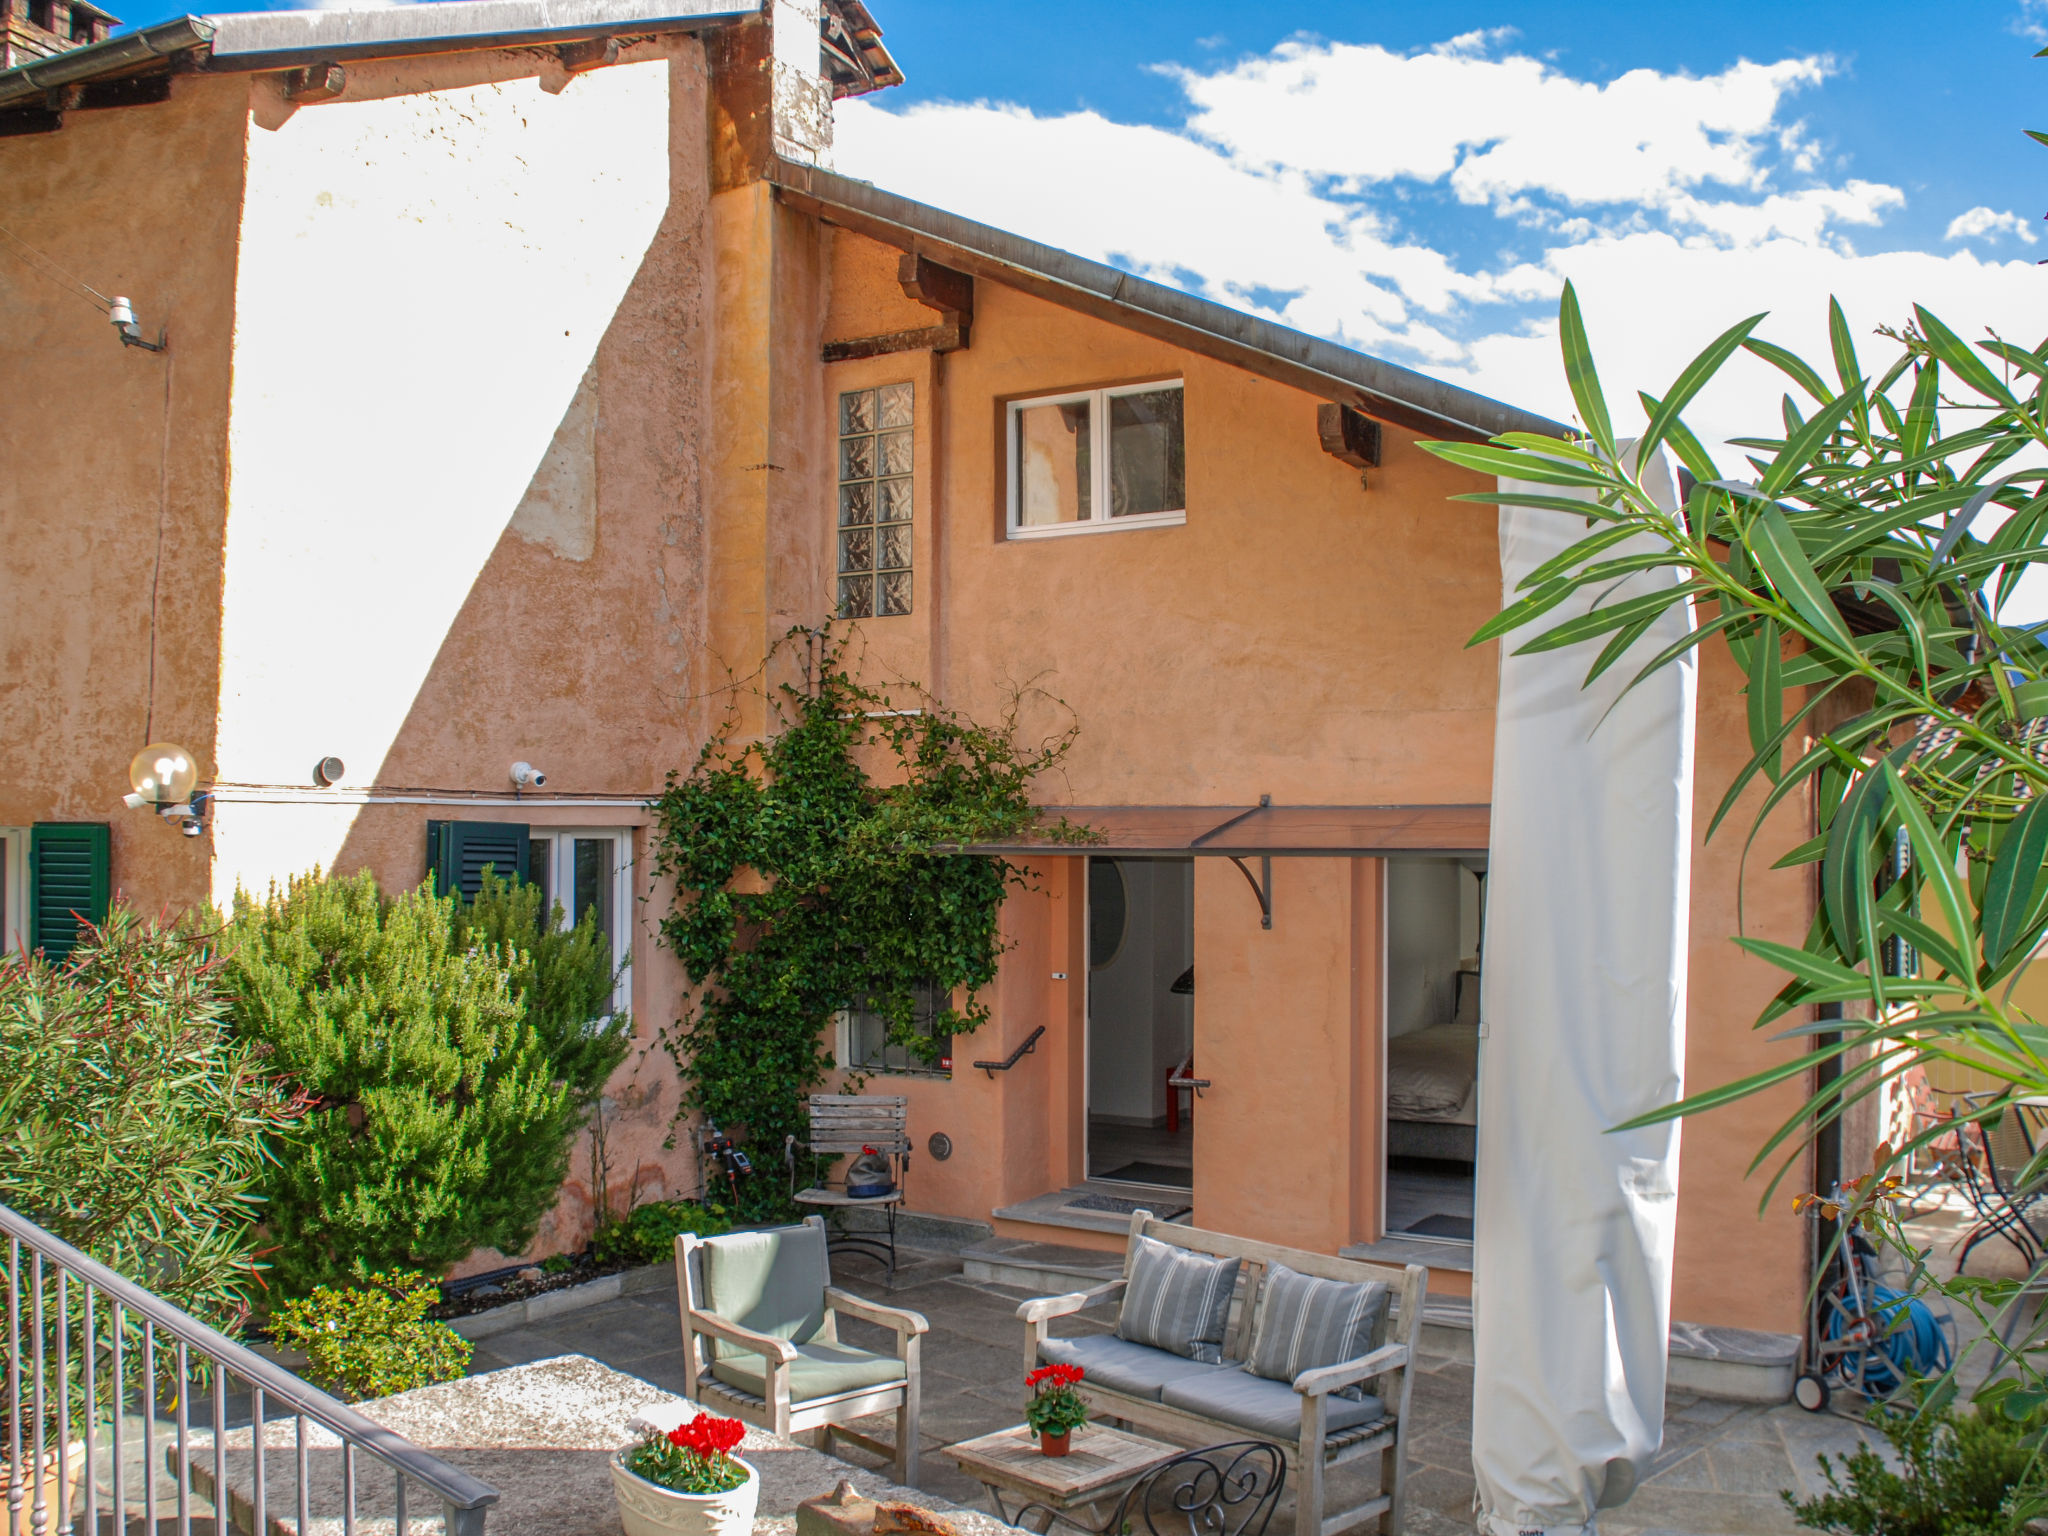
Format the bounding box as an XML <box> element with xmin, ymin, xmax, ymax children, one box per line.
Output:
<box><xmin>838</xmin><ymin>30</ymin><xmax>2048</xmax><ymax>467</ymax></box>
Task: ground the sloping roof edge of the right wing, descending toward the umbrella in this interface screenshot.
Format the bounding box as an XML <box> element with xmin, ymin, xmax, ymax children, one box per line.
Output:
<box><xmin>770</xmin><ymin>160</ymin><xmax>1571</xmax><ymax>440</ymax></box>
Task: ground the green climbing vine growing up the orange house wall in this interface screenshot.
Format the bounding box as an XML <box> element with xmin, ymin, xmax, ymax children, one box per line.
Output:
<box><xmin>653</xmin><ymin>627</ymin><xmax>1085</xmax><ymax>1219</ymax></box>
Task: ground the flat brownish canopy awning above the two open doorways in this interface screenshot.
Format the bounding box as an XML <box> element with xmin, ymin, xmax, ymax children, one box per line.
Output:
<box><xmin>946</xmin><ymin>803</ymin><xmax>1489</xmax><ymax>858</ymax></box>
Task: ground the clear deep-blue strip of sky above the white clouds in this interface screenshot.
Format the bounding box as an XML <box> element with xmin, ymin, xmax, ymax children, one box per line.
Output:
<box><xmin>872</xmin><ymin>0</ymin><xmax>2048</xmax><ymax>254</ymax></box>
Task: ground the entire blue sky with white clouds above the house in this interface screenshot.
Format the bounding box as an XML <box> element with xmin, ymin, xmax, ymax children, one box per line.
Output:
<box><xmin>127</xmin><ymin>0</ymin><xmax>2048</xmax><ymax>456</ymax></box>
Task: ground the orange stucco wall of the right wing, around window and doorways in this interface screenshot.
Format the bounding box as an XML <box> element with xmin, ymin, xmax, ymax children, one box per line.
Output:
<box><xmin>815</xmin><ymin>229</ymin><xmax>1808</xmax><ymax>1331</ymax></box>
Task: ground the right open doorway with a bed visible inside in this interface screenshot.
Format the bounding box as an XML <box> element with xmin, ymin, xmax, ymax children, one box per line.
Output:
<box><xmin>1386</xmin><ymin>854</ymin><xmax>1487</xmax><ymax>1243</ymax></box>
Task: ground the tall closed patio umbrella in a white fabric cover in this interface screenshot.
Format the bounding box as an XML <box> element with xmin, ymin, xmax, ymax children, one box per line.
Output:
<box><xmin>1473</xmin><ymin>455</ymin><xmax>1696</xmax><ymax>1536</ymax></box>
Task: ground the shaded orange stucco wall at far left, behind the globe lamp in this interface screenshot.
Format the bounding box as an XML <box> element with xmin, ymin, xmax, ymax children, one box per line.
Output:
<box><xmin>0</xmin><ymin>76</ymin><xmax>248</xmax><ymax>911</ymax></box>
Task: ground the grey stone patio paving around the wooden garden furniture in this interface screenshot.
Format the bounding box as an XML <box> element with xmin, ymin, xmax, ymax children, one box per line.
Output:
<box><xmin>456</xmin><ymin>1255</ymin><xmax>1866</xmax><ymax>1536</ymax></box>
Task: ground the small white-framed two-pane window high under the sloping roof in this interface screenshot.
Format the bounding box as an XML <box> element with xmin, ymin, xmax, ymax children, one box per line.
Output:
<box><xmin>1008</xmin><ymin>379</ymin><xmax>1188</xmax><ymax>539</ymax></box>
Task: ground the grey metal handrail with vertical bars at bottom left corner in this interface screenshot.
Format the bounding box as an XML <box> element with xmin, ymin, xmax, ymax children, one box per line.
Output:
<box><xmin>0</xmin><ymin>1206</ymin><xmax>498</xmax><ymax>1536</ymax></box>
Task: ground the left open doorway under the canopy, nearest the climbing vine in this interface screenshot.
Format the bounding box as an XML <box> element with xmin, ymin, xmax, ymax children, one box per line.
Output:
<box><xmin>1087</xmin><ymin>858</ymin><xmax>1194</xmax><ymax>1190</ymax></box>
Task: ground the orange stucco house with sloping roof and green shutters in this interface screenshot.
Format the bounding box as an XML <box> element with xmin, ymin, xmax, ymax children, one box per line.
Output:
<box><xmin>0</xmin><ymin>0</ymin><xmax>1810</xmax><ymax>1382</ymax></box>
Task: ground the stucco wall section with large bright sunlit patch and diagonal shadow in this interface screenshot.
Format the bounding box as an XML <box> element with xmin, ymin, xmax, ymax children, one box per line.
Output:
<box><xmin>201</xmin><ymin>37</ymin><xmax>717</xmax><ymax>1270</ymax></box>
